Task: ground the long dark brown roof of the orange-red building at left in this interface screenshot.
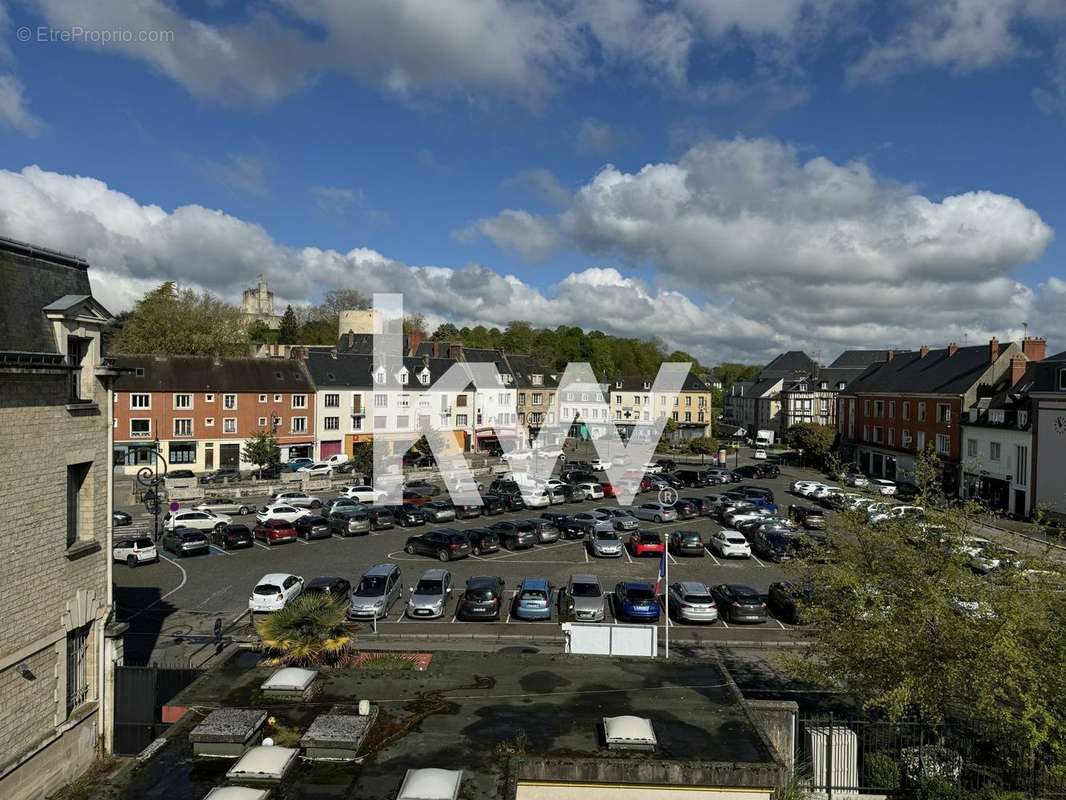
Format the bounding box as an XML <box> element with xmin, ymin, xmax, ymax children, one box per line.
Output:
<box><xmin>114</xmin><ymin>355</ymin><xmax>314</xmax><ymax>393</ymax></box>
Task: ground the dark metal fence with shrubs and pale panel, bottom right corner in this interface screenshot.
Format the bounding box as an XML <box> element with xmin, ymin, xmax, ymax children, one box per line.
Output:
<box><xmin>796</xmin><ymin>715</ymin><xmax>1066</xmax><ymax>800</ymax></box>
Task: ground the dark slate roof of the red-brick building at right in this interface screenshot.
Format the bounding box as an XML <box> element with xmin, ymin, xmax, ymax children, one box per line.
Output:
<box><xmin>847</xmin><ymin>342</ymin><xmax>1006</xmax><ymax>395</ymax></box>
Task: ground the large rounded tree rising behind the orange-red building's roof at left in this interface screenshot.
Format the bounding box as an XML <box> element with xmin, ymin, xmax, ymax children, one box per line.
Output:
<box><xmin>111</xmin><ymin>281</ymin><xmax>248</xmax><ymax>356</ymax></box>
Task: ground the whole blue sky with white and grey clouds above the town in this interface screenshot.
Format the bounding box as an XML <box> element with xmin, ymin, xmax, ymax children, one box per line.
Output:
<box><xmin>0</xmin><ymin>0</ymin><xmax>1066</xmax><ymax>362</ymax></box>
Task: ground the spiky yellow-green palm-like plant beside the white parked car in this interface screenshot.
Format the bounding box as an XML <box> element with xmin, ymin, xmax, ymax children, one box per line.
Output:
<box><xmin>256</xmin><ymin>594</ymin><xmax>352</xmax><ymax>667</ymax></box>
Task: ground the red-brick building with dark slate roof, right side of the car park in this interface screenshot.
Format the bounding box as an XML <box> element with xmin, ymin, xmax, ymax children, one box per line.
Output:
<box><xmin>838</xmin><ymin>338</ymin><xmax>1046</xmax><ymax>494</ymax></box>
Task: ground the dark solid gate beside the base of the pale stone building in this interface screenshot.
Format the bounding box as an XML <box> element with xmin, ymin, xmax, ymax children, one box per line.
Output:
<box><xmin>114</xmin><ymin>665</ymin><xmax>200</xmax><ymax>755</ymax></box>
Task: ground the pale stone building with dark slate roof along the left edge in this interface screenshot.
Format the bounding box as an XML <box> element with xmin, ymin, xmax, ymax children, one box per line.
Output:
<box><xmin>0</xmin><ymin>234</ymin><xmax>113</xmax><ymax>800</ymax></box>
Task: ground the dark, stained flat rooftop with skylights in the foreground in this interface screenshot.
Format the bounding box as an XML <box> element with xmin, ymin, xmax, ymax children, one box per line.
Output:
<box><xmin>120</xmin><ymin>653</ymin><xmax>777</xmax><ymax>800</ymax></box>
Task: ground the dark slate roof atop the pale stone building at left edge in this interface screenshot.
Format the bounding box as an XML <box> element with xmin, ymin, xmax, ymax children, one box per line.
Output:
<box><xmin>0</xmin><ymin>238</ymin><xmax>93</xmax><ymax>354</ymax></box>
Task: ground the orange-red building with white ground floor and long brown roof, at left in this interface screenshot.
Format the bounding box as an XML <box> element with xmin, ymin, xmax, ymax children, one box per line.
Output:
<box><xmin>114</xmin><ymin>355</ymin><xmax>316</xmax><ymax>474</ymax></box>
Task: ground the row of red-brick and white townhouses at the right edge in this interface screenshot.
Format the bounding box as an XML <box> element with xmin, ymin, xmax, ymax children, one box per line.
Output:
<box><xmin>838</xmin><ymin>337</ymin><xmax>1066</xmax><ymax>517</ymax></box>
